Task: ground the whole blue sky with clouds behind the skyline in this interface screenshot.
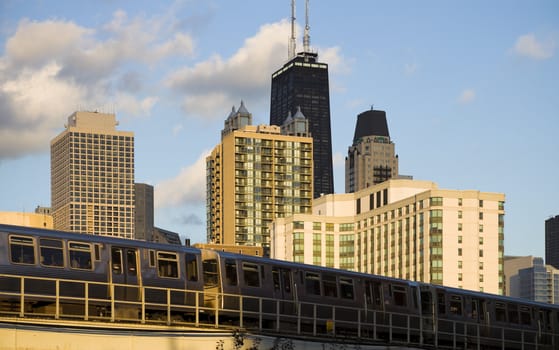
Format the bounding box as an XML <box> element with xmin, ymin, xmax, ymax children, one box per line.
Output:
<box><xmin>0</xmin><ymin>0</ymin><xmax>559</xmax><ymax>257</ymax></box>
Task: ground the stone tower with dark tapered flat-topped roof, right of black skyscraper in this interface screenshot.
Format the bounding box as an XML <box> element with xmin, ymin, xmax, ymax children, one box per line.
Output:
<box><xmin>345</xmin><ymin>108</ymin><xmax>398</xmax><ymax>193</ymax></box>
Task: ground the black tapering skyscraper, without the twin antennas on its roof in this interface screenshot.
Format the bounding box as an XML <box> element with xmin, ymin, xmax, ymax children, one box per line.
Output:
<box><xmin>270</xmin><ymin>52</ymin><xmax>334</xmax><ymax>198</ymax></box>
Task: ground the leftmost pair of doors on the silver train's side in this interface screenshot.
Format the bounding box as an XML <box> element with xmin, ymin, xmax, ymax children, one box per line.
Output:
<box><xmin>110</xmin><ymin>246</ymin><xmax>141</xmax><ymax>301</ymax></box>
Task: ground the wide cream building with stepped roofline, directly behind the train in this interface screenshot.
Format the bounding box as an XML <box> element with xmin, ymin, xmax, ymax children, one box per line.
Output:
<box><xmin>271</xmin><ymin>179</ymin><xmax>505</xmax><ymax>294</ymax></box>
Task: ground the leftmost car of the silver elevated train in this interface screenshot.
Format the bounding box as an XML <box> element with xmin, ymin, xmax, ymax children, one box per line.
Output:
<box><xmin>0</xmin><ymin>225</ymin><xmax>203</xmax><ymax>318</ymax></box>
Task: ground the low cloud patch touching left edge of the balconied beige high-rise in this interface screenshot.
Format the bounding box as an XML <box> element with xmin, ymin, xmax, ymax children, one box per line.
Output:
<box><xmin>154</xmin><ymin>151</ymin><xmax>209</xmax><ymax>208</ymax></box>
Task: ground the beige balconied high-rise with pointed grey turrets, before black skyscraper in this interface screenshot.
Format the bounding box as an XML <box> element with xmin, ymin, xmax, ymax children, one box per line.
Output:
<box><xmin>206</xmin><ymin>102</ymin><xmax>313</xmax><ymax>254</ymax></box>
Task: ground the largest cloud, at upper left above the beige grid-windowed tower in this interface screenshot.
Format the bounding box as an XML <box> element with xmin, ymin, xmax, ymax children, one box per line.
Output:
<box><xmin>0</xmin><ymin>11</ymin><xmax>194</xmax><ymax>159</ymax></box>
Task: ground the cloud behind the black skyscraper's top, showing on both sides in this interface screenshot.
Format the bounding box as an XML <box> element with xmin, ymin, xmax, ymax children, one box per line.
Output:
<box><xmin>166</xmin><ymin>21</ymin><xmax>347</xmax><ymax>119</ymax></box>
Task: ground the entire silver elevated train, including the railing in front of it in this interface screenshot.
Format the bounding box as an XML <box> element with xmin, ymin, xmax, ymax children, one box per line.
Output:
<box><xmin>0</xmin><ymin>224</ymin><xmax>559</xmax><ymax>350</ymax></box>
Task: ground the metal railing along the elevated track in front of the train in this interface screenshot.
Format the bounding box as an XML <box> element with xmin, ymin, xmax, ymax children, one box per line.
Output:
<box><xmin>0</xmin><ymin>275</ymin><xmax>559</xmax><ymax>350</ymax></box>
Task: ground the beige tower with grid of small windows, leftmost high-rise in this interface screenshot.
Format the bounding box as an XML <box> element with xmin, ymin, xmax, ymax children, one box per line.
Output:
<box><xmin>51</xmin><ymin>112</ymin><xmax>134</xmax><ymax>238</ymax></box>
